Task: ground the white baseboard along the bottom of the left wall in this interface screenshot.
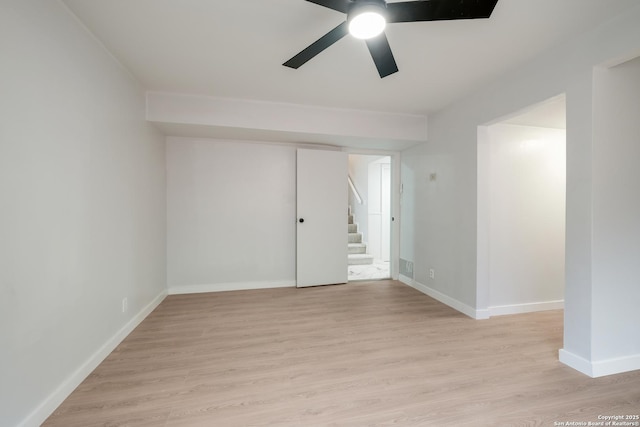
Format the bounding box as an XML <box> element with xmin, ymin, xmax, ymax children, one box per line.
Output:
<box><xmin>19</xmin><ymin>290</ymin><xmax>167</xmax><ymax>427</ymax></box>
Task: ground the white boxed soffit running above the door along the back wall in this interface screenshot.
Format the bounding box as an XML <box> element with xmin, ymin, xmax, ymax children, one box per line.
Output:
<box><xmin>147</xmin><ymin>92</ymin><xmax>427</xmax><ymax>151</ymax></box>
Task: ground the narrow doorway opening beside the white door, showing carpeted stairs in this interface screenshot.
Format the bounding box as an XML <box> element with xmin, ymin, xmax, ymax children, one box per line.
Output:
<box><xmin>348</xmin><ymin>154</ymin><xmax>392</xmax><ymax>281</ymax></box>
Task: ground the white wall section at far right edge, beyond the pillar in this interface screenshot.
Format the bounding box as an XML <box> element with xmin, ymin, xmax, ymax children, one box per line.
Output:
<box><xmin>592</xmin><ymin>58</ymin><xmax>640</xmax><ymax>373</ymax></box>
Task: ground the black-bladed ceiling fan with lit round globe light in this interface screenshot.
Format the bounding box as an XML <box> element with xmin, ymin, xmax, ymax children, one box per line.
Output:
<box><xmin>282</xmin><ymin>0</ymin><xmax>498</xmax><ymax>78</ymax></box>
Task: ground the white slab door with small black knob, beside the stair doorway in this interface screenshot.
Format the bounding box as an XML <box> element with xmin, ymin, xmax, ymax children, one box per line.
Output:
<box><xmin>296</xmin><ymin>149</ymin><xmax>349</xmax><ymax>287</ymax></box>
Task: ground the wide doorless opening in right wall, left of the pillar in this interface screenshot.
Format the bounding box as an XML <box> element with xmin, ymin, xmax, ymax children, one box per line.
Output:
<box><xmin>477</xmin><ymin>95</ymin><xmax>566</xmax><ymax>317</ymax></box>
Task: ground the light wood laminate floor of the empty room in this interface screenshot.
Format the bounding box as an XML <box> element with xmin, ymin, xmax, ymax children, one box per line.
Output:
<box><xmin>44</xmin><ymin>281</ymin><xmax>640</xmax><ymax>427</ymax></box>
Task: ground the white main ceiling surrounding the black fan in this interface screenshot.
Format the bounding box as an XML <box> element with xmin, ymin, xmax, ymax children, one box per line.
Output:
<box><xmin>64</xmin><ymin>0</ymin><xmax>638</xmax><ymax>120</ymax></box>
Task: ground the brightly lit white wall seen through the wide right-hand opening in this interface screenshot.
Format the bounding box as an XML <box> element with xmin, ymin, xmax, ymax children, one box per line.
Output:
<box><xmin>479</xmin><ymin>124</ymin><xmax>566</xmax><ymax>314</ymax></box>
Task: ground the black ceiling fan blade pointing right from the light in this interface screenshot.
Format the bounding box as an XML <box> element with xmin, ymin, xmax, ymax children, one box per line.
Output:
<box><xmin>387</xmin><ymin>0</ymin><xmax>498</xmax><ymax>22</ymax></box>
